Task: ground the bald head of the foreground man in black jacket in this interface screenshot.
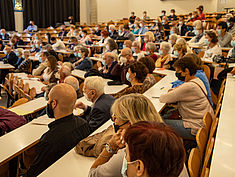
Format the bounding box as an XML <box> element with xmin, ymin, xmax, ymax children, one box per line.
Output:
<box><xmin>48</xmin><ymin>83</ymin><xmax>77</xmax><ymax>118</ymax></box>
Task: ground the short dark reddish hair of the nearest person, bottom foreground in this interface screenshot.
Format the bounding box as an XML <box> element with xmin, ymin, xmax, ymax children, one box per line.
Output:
<box><xmin>124</xmin><ymin>121</ymin><xmax>186</xmax><ymax>177</ymax></box>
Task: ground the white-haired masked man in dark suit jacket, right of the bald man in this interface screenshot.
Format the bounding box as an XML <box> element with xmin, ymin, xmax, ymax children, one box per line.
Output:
<box><xmin>75</xmin><ymin>76</ymin><xmax>114</xmax><ymax>132</ymax></box>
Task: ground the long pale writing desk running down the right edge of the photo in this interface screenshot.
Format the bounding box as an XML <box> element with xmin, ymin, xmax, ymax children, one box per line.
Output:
<box><xmin>210</xmin><ymin>74</ymin><xmax>235</xmax><ymax>177</ymax></box>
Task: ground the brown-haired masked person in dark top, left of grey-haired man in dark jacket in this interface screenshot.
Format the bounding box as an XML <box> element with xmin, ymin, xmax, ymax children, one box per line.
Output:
<box><xmin>74</xmin><ymin>47</ymin><xmax>93</xmax><ymax>71</ymax></box>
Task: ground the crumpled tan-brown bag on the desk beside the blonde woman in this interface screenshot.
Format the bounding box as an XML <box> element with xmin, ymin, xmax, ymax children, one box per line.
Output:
<box><xmin>75</xmin><ymin>125</ymin><xmax>115</xmax><ymax>157</ymax></box>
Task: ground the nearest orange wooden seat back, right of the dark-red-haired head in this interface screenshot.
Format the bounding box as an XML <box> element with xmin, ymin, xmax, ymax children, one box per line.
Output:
<box><xmin>188</xmin><ymin>148</ymin><xmax>201</xmax><ymax>177</ymax></box>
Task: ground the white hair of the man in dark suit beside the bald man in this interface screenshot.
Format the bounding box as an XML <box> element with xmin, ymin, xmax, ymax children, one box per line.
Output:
<box><xmin>84</xmin><ymin>76</ymin><xmax>105</xmax><ymax>94</ymax></box>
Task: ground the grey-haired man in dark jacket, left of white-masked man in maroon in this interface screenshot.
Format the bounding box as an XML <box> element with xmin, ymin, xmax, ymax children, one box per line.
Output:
<box><xmin>97</xmin><ymin>52</ymin><xmax>117</xmax><ymax>80</ymax></box>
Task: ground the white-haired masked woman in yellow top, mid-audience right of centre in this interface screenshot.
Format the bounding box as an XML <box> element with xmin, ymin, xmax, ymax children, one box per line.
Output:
<box><xmin>155</xmin><ymin>42</ymin><xmax>172</xmax><ymax>69</ymax></box>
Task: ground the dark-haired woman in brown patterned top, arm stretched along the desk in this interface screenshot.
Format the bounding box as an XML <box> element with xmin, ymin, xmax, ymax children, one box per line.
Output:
<box><xmin>114</xmin><ymin>61</ymin><xmax>148</xmax><ymax>98</ymax></box>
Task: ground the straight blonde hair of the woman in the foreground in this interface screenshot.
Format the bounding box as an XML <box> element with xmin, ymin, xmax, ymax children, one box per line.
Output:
<box><xmin>111</xmin><ymin>93</ymin><xmax>163</xmax><ymax>124</ymax></box>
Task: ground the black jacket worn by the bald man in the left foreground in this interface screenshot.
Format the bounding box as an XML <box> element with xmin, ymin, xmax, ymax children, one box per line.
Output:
<box><xmin>24</xmin><ymin>114</ymin><xmax>90</xmax><ymax>177</ymax></box>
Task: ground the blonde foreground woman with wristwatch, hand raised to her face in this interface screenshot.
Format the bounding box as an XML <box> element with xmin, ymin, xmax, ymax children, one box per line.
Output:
<box><xmin>89</xmin><ymin>94</ymin><xmax>165</xmax><ymax>177</ymax></box>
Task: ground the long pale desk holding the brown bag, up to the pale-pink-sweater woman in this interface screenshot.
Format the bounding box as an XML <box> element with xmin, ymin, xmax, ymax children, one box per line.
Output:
<box><xmin>39</xmin><ymin>69</ymin><xmax>176</xmax><ymax>177</ymax></box>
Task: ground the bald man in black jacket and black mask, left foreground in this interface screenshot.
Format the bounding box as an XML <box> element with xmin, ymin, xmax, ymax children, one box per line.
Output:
<box><xmin>24</xmin><ymin>84</ymin><xmax>90</xmax><ymax>177</ymax></box>
